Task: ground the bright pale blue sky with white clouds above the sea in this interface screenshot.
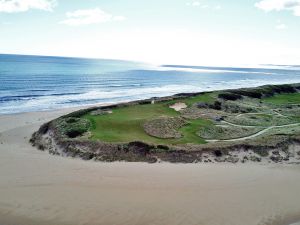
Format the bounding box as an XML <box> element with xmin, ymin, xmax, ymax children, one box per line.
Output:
<box><xmin>0</xmin><ymin>0</ymin><xmax>300</xmax><ymax>66</ymax></box>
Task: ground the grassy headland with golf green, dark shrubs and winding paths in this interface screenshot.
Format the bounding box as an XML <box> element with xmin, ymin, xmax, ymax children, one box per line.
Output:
<box><xmin>33</xmin><ymin>84</ymin><xmax>300</xmax><ymax>161</ymax></box>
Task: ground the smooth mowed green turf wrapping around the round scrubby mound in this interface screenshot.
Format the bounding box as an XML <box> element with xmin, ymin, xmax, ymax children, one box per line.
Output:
<box><xmin>84</xmin><ymin>100</ymin><xmax>211</xmax><ymax>144</ymax></box>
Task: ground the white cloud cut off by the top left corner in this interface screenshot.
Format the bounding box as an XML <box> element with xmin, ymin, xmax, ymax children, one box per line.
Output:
<box><xmin>0</xmin><ymin>0</ymin><xmax>56</xmax><ymax>13</ymax></box>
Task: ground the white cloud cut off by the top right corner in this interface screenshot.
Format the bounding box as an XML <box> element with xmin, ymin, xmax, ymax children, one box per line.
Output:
<box><xmin>255</xmin><ymin>0</ymin><xmax>300</xmax><ymax>16</ymax></box>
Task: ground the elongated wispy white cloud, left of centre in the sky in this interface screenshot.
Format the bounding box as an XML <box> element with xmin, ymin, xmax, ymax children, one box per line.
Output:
<box><xmin>60</xmin><ymin>8</ymin><xmax>126</xmax><ymax>26</ymax></box>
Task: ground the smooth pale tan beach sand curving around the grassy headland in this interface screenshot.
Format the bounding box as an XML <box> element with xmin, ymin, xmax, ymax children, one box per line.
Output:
<box><xmin>0</xmin><ymin>108</ymin><xmax>300</xmax><ymax>225</ymax></box>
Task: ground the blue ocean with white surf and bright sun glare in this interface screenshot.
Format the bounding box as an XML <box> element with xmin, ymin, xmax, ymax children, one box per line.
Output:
<box><xmin>0</xmin><ymin>54</ymin><xmax>300</xmax><ymax>114</ymax></box>
